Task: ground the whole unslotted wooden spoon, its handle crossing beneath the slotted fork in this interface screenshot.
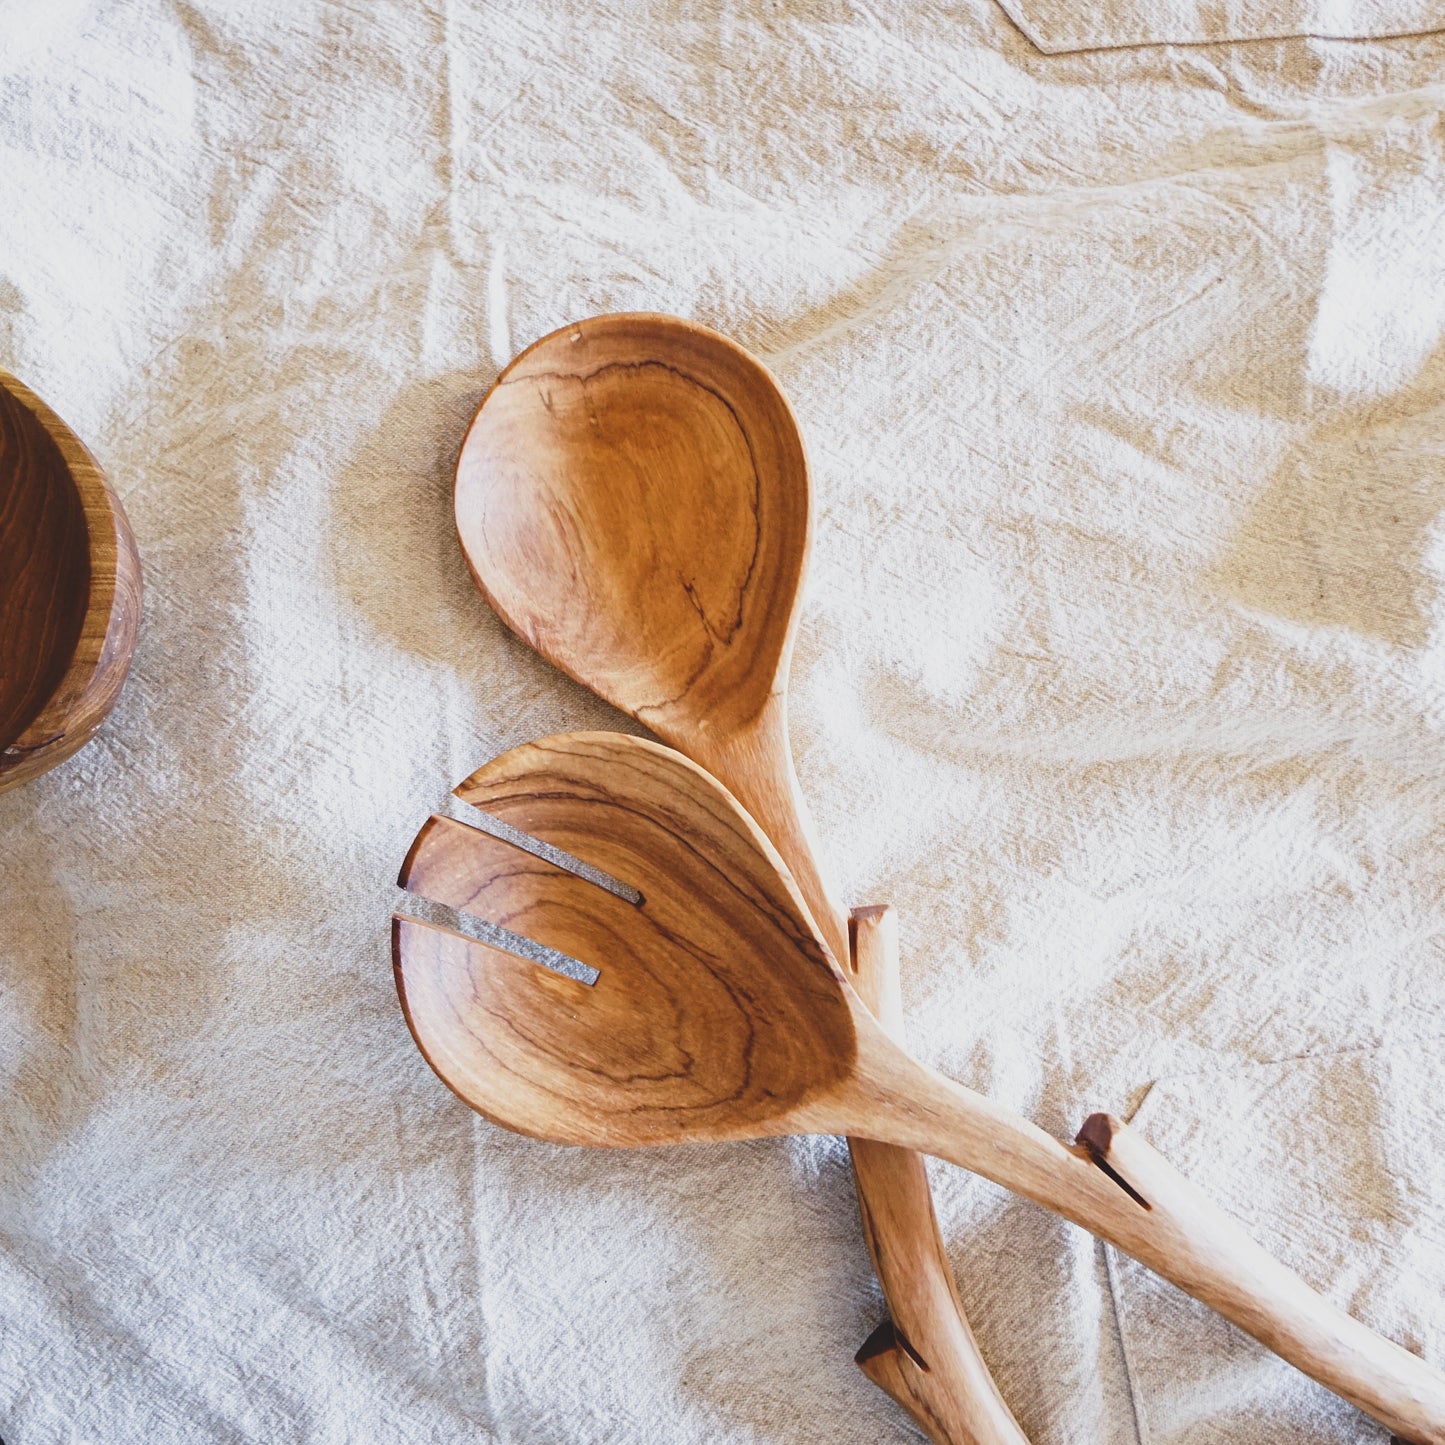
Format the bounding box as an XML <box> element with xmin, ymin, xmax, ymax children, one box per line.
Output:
<box><xmin>457</xmin><ymin>315</ymin><xmax>1027</xmax><ymax>1445</ymax></box>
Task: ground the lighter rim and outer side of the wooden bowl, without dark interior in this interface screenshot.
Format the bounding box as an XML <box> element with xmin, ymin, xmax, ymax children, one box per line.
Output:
<box><xmin>0</xmin><ymin>368</ymin><xmax>140</xmax><ymax>789</ymax></box>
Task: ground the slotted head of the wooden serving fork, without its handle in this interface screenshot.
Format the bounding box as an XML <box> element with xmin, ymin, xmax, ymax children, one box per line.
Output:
<box><xmin>393</xmin><ymin>733</ymin><xmax>857</xmax><ymax>1146</ymax></box>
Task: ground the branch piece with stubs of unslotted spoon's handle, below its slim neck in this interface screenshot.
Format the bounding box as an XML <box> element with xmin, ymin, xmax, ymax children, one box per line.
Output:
<box><xmin>848</xmin><ymin>905</ymin><xmax>1027</xmax><ymax>1445</ymax></box>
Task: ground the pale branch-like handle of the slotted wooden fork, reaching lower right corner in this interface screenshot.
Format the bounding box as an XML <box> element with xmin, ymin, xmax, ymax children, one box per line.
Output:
<box><xmin>848</xmin><ymin>1057</ymin><xmax>1445</xmax><ymax>1445</ymax></box>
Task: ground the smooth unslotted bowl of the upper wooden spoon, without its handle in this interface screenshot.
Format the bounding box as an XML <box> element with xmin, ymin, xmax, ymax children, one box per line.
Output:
<box><xmin>455</xmin><ymin>316</ymin><xmax>809</xmax><ymax>733</ymax></box>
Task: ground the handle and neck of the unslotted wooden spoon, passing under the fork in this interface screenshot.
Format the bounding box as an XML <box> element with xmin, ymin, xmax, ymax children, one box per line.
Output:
<box><xmin>693</xmin><ymin>694</ymin><xmax>1027</xmax><ymax>1445</ymax></box>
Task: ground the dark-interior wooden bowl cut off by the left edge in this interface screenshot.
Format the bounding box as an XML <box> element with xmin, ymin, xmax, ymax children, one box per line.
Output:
<box><xmin>0</xmin><ymin>371</ymin><xmax>140</xmax><ymax>792</ymax></box>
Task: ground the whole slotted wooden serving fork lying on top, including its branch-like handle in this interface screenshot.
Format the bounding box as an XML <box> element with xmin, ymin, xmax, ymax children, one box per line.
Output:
<box><xmin>393</xmin><ymin>733</ymin><xmax>1445</xmax><ymax>1445</ymax></box>
